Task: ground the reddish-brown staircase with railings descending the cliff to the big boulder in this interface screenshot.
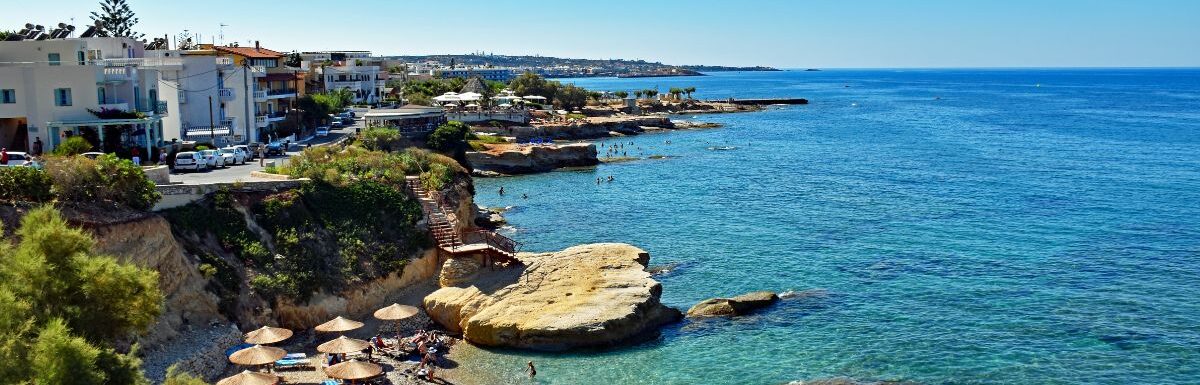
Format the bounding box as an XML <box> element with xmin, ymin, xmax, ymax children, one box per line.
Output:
<box><xmin>404</xmin><ymin>176</ymin><xmax>521</xmax><ymax>264</ymax></box>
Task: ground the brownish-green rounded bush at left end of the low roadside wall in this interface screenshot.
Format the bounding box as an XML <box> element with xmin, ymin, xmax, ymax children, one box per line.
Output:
<box><xmin>46</xmin><ymin>154</ymin><xmax>161</xmax><ymax>210</ymax></box>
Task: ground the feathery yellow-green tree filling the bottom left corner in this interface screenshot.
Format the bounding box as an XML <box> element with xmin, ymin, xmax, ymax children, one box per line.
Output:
<box><xmin>0</xmin><ymin>206</ymin><xmax>163</xmax><ymax>385</ymax></box>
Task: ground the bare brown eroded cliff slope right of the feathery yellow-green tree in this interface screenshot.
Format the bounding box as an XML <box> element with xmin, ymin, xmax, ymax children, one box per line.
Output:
<box><xmin>90</xmin><ymin>215</ymin><xmax>224</xmax><ymax>345</ymax></box>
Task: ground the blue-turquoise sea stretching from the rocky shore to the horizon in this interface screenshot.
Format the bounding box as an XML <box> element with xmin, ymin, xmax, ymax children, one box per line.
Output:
<box><xmin>461</xmin><ymin>70</ymin><xmax>1200</xmax><ymax>385</ymax></box>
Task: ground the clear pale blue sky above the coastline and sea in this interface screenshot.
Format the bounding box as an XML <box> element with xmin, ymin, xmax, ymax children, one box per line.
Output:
<box><xmin>9</xmin><ymin>0</ymin><xmax>1200</xmax><ymax>68</ymax></box>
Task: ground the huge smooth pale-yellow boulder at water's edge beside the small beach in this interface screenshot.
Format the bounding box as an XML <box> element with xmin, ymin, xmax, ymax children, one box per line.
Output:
<box><xmin>425</xmin><ymin>243</ymin><xmax>682</xmax><ymax>350</ymax></box>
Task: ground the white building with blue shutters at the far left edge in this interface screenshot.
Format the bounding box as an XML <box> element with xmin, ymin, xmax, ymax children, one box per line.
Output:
<box><xmin>0</xmin><ymin>34</ymin><xmax>172</xmax><ymax>154</ymax></box>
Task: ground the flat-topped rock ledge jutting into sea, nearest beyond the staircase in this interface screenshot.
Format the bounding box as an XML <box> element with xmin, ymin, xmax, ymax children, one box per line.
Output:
<box><xmin>467</xmin><ymin>143</ymin><xmax>600</xmax><ymax>174</ymax></box>
